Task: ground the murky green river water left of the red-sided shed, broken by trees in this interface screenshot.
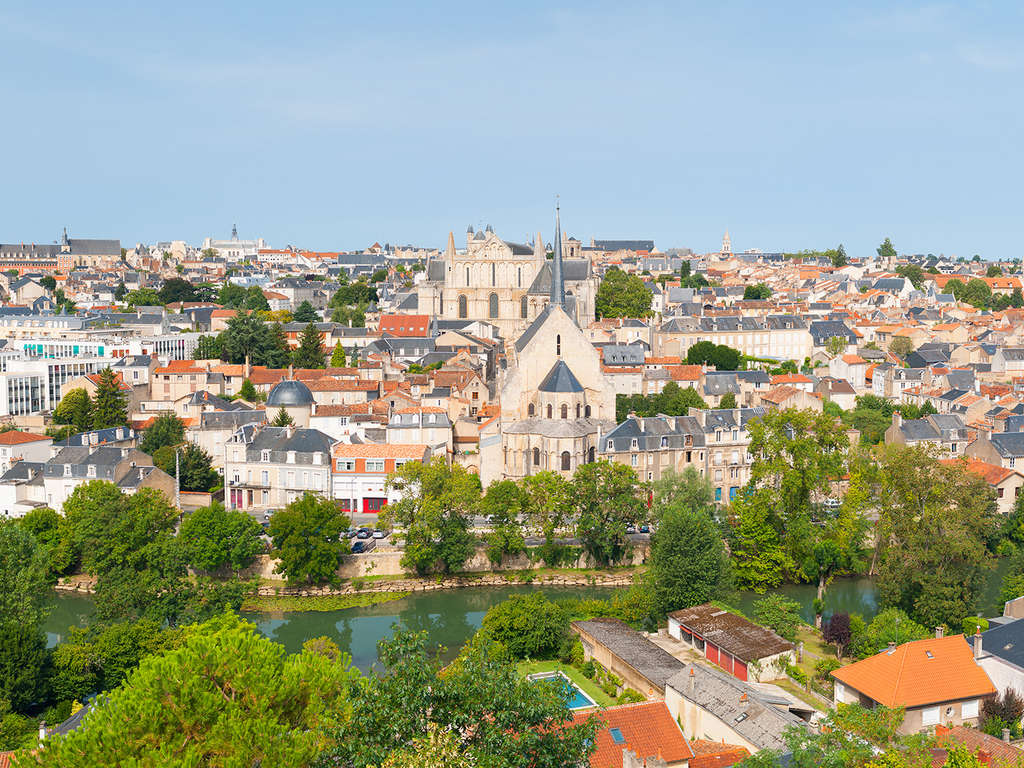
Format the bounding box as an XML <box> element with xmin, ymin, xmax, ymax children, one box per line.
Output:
<box><xmin>46</xmin><ymin>585</ymin><xmax>614</xmax><ymax>670</ymax></box>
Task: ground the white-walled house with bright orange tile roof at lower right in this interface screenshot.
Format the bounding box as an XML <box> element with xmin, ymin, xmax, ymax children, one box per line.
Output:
<box><xmin>833</xmin><ymin>629</ymin><xmax>996</xmax><ymax>734</ymax></box>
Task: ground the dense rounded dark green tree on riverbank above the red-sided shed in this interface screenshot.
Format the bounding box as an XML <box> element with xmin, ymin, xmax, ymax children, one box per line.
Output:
<box><xmin>648</xmin><ymin>497</ymin><xmax>730</xmax><ymax>615</ymax></box>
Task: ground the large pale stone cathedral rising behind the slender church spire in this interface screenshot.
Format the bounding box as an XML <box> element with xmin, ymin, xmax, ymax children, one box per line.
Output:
<box><xmin>418</xmin><ymin>225</ymin><xmax>600</xmax><ymax>339</ymax></box>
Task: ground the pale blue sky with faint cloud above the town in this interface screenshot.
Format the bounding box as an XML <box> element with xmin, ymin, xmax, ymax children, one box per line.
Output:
<box><xmin>0</xmin><ymin>0</ymin><xmax>1024</xmax><ymax>259</ymax></box>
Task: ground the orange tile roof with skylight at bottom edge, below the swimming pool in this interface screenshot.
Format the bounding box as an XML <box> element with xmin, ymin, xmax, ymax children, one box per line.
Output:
<box><xmin>572</xmin><ymin>701</ymin><xmax>693</xmax><ymax>768</ymax></box>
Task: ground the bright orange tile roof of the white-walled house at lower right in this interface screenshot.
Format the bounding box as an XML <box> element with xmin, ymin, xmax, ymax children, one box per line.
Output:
<box><xmin>833</xmin><ymin>635</ymin><xmax>995</xmax><ymax>707</ymax></box>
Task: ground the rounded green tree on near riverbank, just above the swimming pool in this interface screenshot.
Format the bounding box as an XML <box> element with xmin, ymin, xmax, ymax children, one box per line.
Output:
<box><xmin>480</xmin><ymin>592</ymin><xmax>569</xmax><ymax>658</ymax></box>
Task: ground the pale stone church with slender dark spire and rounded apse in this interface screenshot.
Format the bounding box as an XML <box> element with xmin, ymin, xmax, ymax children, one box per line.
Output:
<box><xmin>480</xmin><ymin>211</ymin><xmax>615</xmax><ymax>484</ymax></box>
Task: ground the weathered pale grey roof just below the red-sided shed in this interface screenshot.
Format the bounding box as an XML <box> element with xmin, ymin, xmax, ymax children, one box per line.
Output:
<box><xmin>668</xmin><ymin>664</ymin><xmax>807</xmax><ymax>750</ymax></box>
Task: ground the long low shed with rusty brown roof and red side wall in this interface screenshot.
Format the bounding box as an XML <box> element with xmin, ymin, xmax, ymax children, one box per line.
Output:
<box><xmin>669</xmin><ymin>603</ymin><xmax>795</xmax><ymax>682</ymax></box>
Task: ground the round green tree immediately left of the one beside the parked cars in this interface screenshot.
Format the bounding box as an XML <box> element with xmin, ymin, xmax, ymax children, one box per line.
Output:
<box><xmin>178</xmin><ymin>502</ymin><xmax>263</xmax><ymax>572</ymax></box>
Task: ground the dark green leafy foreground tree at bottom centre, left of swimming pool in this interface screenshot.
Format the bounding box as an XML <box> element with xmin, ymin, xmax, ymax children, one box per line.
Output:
<box><xmin>324</xmin><ymin>632</ymin><xmax>597</xmax><ymax>768</ymax></box>
